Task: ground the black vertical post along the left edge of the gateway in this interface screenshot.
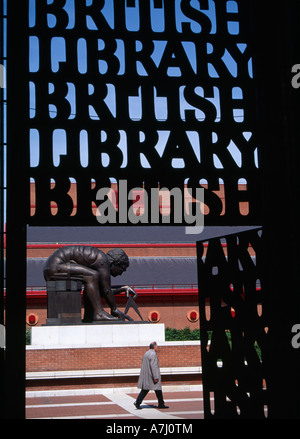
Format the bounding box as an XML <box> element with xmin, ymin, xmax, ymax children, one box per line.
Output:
<box><xmin>5</xmin><ymin>1</ymin><xmax>28</xmax><ymax>419</ymax></box>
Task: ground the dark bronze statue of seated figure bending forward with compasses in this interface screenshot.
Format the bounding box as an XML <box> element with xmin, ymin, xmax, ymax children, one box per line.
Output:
<box><xmin>44</xmin><ymin>245</ymin><xmax>137</xmax><ymax>321</ymax></box>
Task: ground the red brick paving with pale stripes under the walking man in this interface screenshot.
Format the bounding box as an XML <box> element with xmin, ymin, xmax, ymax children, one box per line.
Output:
<box><xmin>26</xmin><ymin>389</ymin><xmax>204</xmax><ymax>420</ymax></box>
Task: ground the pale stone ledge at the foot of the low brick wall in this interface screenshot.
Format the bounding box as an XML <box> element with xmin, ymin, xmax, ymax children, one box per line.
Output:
<box><xmin>26</xmin><ymin>366</ymin><xmax>202</xmax><ymax>380</ymax></box>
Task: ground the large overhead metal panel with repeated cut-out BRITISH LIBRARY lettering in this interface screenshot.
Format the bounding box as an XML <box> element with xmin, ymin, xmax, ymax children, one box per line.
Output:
<box><xmin>21</xmin><ymin>0</ymin><xmax>262</xmax><ymax>225</ymax></box>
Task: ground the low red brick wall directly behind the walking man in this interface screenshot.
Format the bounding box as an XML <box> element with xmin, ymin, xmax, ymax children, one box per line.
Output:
<box><xmin>26</xmin><ymin>342</ymin><xmax>201</xmax><ymax>372</ymax></box>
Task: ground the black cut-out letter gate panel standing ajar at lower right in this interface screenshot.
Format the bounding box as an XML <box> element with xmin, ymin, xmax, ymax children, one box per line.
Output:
<box><xmin>197</xmin><ymin>229</ymin><xmax>271</xmax><ymax>418</ymax></box>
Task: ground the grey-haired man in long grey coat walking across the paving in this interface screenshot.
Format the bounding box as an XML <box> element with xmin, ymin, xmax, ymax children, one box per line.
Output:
<box><xmin>134</xmin><ymin>341</ymin><xmax>169</xmax><ymax>409</ymax></box>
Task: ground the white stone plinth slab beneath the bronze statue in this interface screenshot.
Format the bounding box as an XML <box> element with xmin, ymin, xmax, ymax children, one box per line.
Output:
<box><xmin>31</xmin><ymin>321</ymin><xmax>165</xmax><ymax>348</ymax></box>
